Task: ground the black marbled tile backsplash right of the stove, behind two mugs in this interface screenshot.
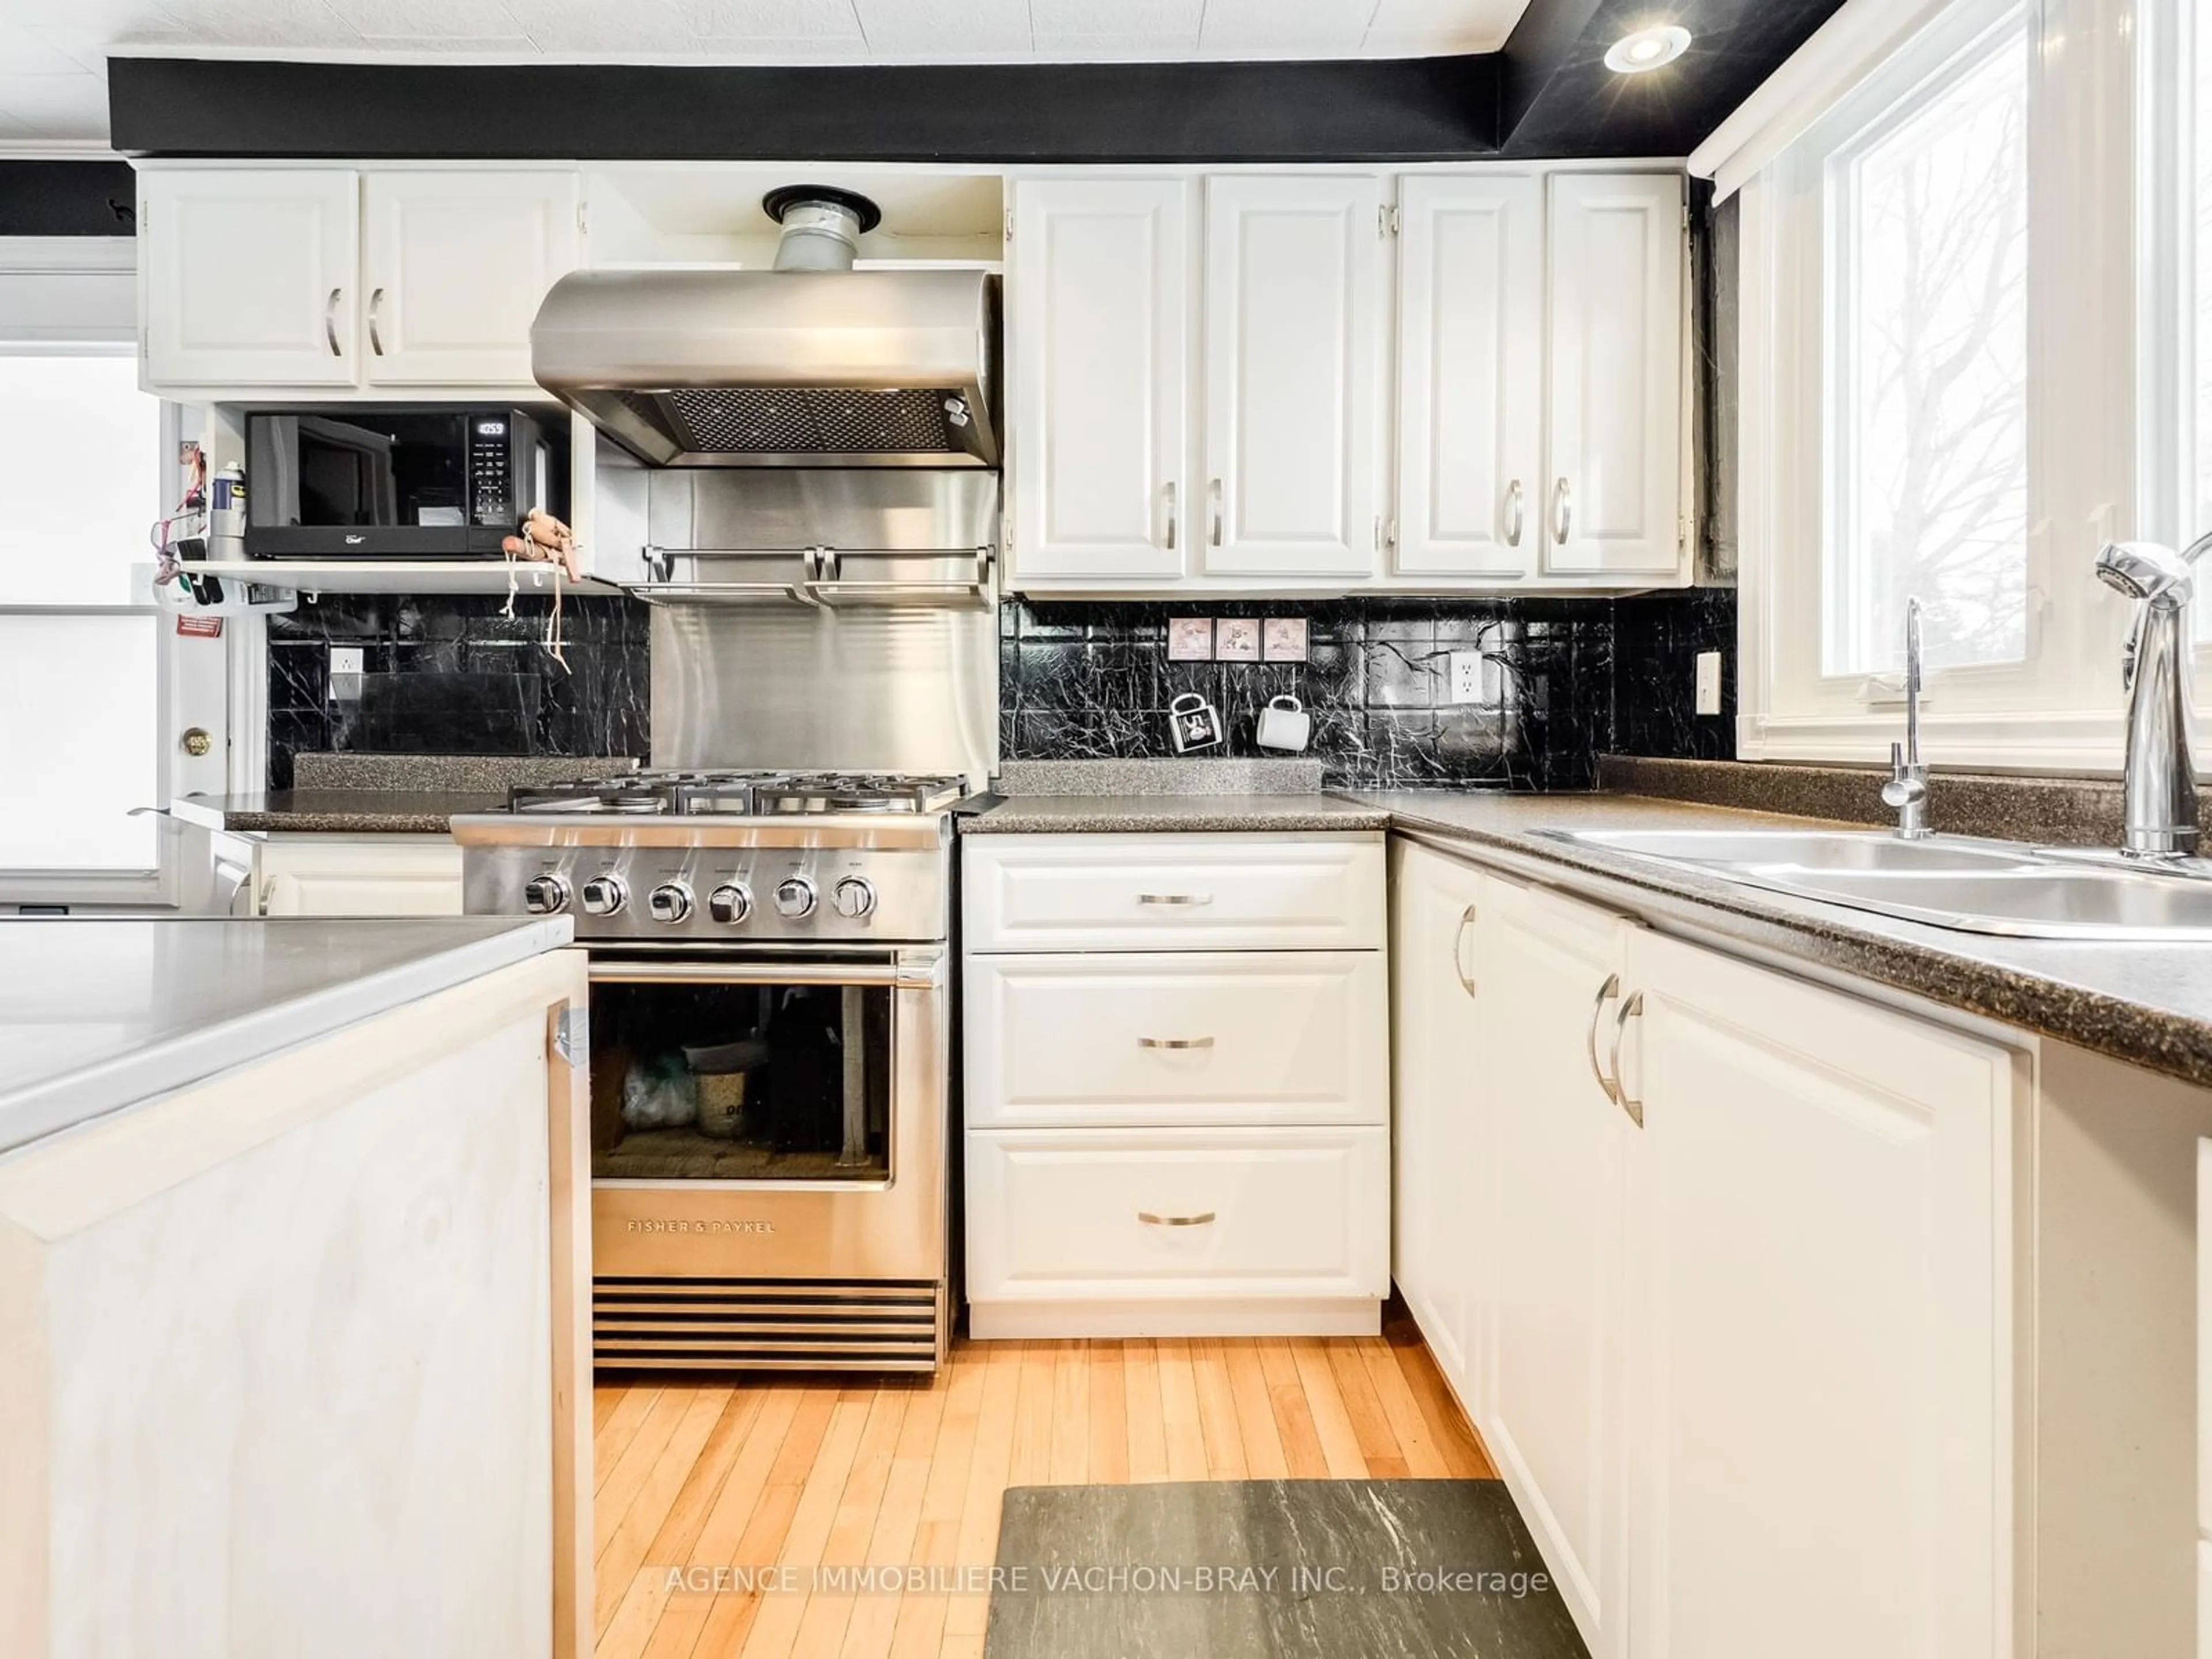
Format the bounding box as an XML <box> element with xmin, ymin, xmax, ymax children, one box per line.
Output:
<box><xmin>998</xmin><ymin>588</ymin><xmax>1736</xmax><ymax>790</ymax></box>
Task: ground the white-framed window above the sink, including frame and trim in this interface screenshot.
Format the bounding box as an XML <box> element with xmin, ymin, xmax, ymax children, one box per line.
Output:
<box><xmin>1734</xmin><ymin>0</ymin><xmax>2150</xmax><ymax>772</ymax></box>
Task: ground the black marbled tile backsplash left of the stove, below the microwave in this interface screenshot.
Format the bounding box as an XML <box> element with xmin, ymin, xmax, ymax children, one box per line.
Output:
<box><xmin>268</xmin><ymin>595</ymin><xmax>650</xmax><ymax>790</ymax></box>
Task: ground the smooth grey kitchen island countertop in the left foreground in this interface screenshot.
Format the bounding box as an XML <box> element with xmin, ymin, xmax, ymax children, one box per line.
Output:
<box><xmin>0</xmin><ymin>916</ymin><xmax>573</xmax><ymax>1154</ymax></box>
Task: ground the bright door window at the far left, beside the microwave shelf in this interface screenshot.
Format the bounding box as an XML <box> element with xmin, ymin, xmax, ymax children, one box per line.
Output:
<box><xmin>0</xmin><ymin>319</ymin><xmax>164</xmax><ymax>903</ymax></box>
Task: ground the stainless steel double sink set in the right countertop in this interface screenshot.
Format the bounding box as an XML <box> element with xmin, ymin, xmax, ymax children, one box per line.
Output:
<box><xmin>1541</xmin><ymin>830</ymin><xmax>2212</xmax><ymax>942</ymax></box>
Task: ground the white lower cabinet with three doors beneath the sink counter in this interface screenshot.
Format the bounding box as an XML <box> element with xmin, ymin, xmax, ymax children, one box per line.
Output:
<box><xmin>1391</xmin><ymin>845</ymin><xmax>2026</xmax><ymax>1659</ymax></box>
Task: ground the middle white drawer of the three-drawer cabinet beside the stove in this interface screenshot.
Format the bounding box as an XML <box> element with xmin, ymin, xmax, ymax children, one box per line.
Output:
<box><xmin>962</xmin><ymin>951</ymin><xmax>1389</xmax><ymax>1128</ymax></box>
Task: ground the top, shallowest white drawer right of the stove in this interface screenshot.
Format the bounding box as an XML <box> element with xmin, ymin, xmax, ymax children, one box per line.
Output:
<box><xmin>964</xmin><ymin>836</ymin><xmax>1382</xmax><ymax>951</ymax></box>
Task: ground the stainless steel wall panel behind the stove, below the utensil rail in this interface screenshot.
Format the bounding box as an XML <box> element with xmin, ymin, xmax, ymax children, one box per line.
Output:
<box><xmin>653</xmin><ymin>604</ymin><xmax>998</xmax><ymax>785</ymax></box>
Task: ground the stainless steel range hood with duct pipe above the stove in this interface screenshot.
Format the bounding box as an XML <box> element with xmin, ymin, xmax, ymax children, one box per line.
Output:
<box><xmin>531</xmin><ymin>186</ymin><xmax>1000</xmax><ymax>467</ymax></box>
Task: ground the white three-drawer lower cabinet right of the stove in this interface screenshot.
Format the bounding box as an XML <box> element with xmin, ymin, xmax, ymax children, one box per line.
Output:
<box><xmin>962</xmin><ymin>834</ymin><xmax>1389</xmax><ymax>1338</ymax></box>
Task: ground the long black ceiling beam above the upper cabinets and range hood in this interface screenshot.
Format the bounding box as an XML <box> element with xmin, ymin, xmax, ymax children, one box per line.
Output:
<box><xmin>108</xmin><ymin>55</ymin><xmax>1498</xmax><ymax>164</ymax></box>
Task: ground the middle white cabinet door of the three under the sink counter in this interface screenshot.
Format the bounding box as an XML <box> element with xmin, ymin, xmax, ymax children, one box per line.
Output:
<box><xmin>1469</xmin><ymin>880</ymin><xmax>1637</xmax><ymax>1659</ymax></box>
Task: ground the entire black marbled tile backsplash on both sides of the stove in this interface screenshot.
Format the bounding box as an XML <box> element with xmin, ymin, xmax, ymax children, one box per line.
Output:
<box><xmin>270</xmin><ymin>588</ymin><xmax>1736</xmax><ymax>790</ymax></box>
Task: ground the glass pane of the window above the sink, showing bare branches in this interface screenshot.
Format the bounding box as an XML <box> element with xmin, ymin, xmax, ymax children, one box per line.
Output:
<box><xmin>1820</xmin><ymin>29</ymin><xmax>2028</xmax><ymax>675</ymax></box>
